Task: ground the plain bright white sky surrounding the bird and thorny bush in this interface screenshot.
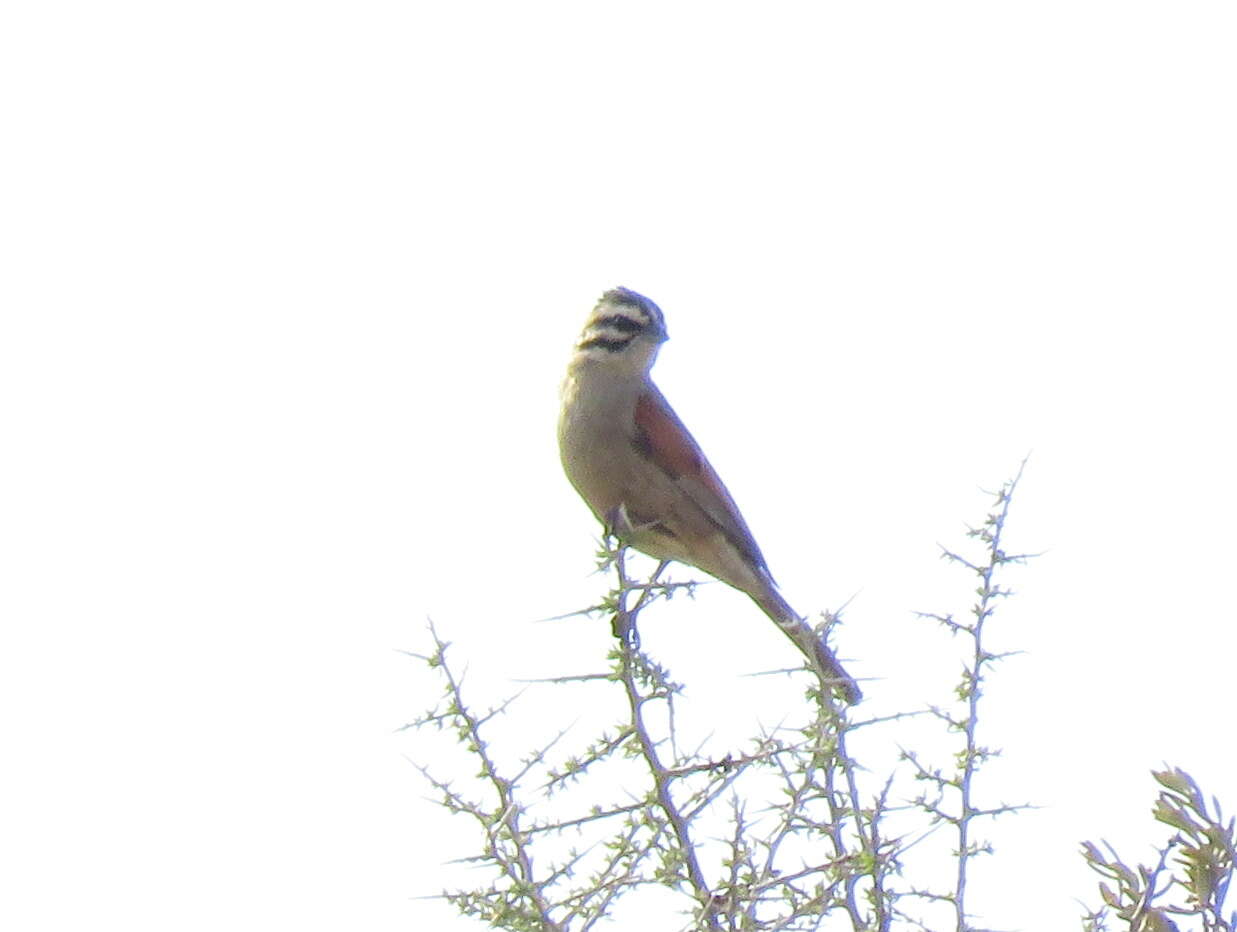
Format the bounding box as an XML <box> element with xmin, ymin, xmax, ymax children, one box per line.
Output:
<box><xmin>0</xmin><ymin>0</ymin><xmax>1237</xmax><ymax>931</ymax></box>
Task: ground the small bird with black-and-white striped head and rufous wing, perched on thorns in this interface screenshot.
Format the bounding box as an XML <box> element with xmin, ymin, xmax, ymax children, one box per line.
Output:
<box><xmin>558</xmin><ymin>287</ymin><xmax>862</xmax><ymax>704</ymax></box>
